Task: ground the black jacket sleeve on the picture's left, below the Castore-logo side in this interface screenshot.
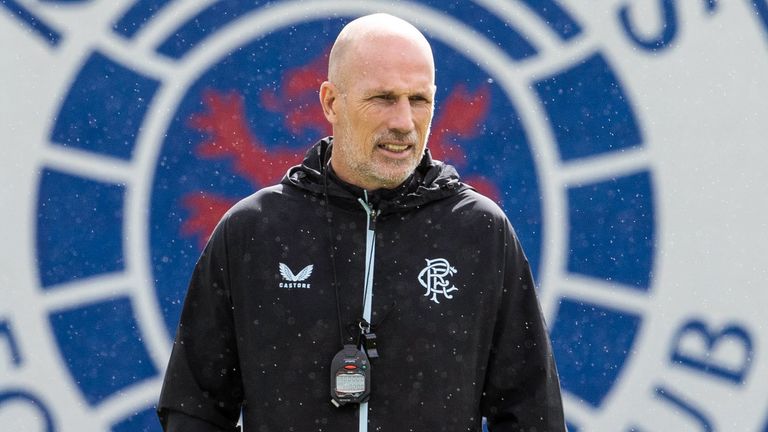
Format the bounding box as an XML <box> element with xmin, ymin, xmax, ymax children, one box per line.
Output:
<box><xmin>158</xmin><ymin>218</ymin><xmax>243</xmax><ymax>432</ymax></box>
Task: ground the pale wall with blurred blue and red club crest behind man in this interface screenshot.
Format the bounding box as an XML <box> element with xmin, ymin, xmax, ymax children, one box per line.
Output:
<box><xmin>0</xmin><ymin>0</ymin><xmax>768</xmax><ymax>432</ymax></box>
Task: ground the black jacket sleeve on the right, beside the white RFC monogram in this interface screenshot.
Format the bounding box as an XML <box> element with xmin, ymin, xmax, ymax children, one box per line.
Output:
<box><xmin>481</xmin><ymin>222</ymin><xmax>566</xmax><ymax>432</ymax></box>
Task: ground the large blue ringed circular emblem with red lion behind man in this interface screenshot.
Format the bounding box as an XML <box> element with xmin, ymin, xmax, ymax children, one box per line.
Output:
<box><xmin>37</xmin><ymin>0</ymin><xmax>656</xmax><ymax>431</ymax></box>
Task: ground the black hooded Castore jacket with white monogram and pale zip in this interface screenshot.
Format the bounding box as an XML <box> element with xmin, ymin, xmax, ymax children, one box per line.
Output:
<box><xmin>158</xmin><ymin>138</ymin><xmax>565</xmax><ymax>432</ymax></box>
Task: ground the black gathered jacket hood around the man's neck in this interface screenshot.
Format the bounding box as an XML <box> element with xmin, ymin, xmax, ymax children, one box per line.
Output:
<box><xmin>281</xmin><ymin>137</ymin><xmax>472</xmax><ymax>212</ymax></box>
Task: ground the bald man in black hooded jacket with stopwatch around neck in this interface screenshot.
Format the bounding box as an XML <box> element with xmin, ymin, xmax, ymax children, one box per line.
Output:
<box><xmin>158</xmin><ymin>14</ymin><xmax>564</xmax><ymax>432</ymax></box>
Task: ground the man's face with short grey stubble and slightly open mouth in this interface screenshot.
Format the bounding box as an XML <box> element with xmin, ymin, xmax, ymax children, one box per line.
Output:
<box><xmin>324</xmin><ymin>38</ymin><xmax>435</xmax><ymax>190</ymax></box>
